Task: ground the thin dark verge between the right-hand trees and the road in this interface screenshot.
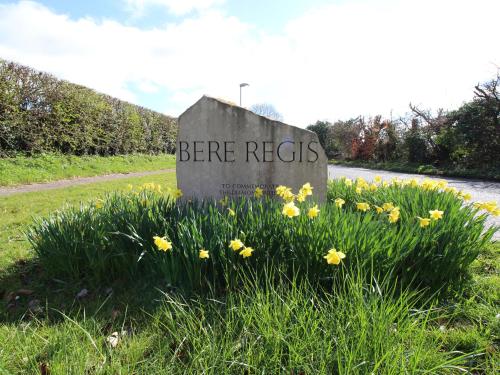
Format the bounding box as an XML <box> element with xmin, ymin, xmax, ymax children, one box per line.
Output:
<box><xmin>329</xmin><ymin>160</ymin><xmax>500</xmax><ymax>181</ymax></box>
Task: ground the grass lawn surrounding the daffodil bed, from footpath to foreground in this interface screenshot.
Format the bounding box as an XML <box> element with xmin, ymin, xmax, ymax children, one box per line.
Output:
<box><xmin>0</xmin><ymin>173</ymin><xmax>500</xmax><ymax>374</ymax></box>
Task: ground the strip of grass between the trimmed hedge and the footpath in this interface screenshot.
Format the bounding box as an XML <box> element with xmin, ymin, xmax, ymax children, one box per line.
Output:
<box><xmin>0</xmin><ymin>154</ymin><xmax>175</xmax><ymax>186</ymax></box>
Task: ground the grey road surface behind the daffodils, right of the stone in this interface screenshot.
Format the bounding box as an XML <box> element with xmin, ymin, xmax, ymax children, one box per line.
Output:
<box><xmin>328</xmin><ymin>165</ymin><xmax>500</xmax><ymax>240</ymax></box>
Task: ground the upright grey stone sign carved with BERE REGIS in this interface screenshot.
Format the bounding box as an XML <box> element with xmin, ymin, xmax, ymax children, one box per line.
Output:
<box><xmin>176</xmin><ymin>96</ymin><xmax>327</xmax><ymax>201</ymax></box>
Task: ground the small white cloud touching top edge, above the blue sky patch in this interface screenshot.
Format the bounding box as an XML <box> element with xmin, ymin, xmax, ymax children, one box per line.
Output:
<box><xmin>124</xmin><ymin>0</ymin><xmax>224</xmax><ymax>16</ymax></box>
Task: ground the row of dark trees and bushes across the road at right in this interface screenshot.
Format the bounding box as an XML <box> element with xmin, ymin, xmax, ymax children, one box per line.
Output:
<box><xmin>308</xmin><ymin>75</ymin><xmax>500</xmax><ymax>175</ymax></box>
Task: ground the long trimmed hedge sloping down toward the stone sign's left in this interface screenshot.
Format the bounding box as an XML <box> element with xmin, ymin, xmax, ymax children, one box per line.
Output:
<box><xmin>0</xmin><ymin>59</ymin><xmax>177</xmax><ymax>156</ymax></box>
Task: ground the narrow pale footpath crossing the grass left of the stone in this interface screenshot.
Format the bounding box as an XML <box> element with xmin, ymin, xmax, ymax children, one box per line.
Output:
<box><xmin>0</xmin><ymin>169</ymin><xmax>175</xmax><ymax>197</ymax></box>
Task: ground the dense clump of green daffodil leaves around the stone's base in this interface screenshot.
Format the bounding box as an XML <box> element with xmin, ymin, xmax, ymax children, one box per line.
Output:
<box><xmin>28</xmin><ymin>180</ymin><xmax>495</xmax><ymax>290</ymax></box>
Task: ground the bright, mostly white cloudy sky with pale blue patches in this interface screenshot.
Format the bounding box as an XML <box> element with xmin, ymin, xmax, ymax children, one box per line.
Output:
<box><xmin>0</xmin><ymin>0</ymin><xmax>500</xmax><ymax>127</ymax></box>
